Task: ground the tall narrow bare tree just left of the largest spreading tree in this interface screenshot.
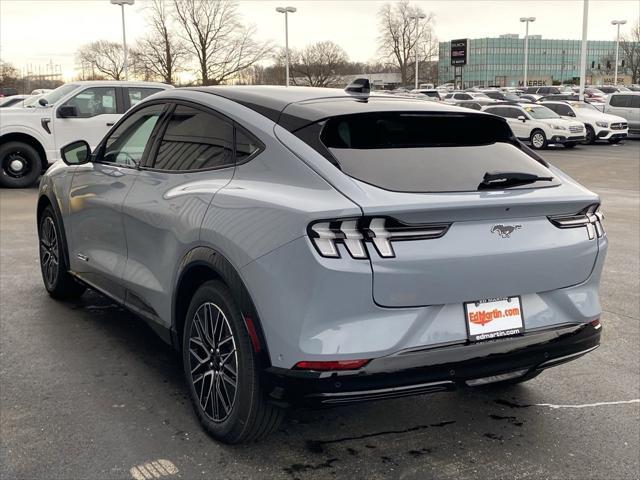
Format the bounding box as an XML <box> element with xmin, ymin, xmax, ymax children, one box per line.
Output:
<box><xmin>134</xmin><ymin>0</ymin><xmax>189</xmax><ymax>84</ymax></box>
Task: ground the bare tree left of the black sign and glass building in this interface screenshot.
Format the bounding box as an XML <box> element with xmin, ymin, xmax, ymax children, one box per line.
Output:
<box><xmin>378</xmin><ymin>0</ymin><xmax>437</xmax><ymax>83</ymax></box>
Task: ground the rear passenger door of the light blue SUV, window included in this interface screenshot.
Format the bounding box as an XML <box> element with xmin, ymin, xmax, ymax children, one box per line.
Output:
<box><xmin>123</xmin><ymin>102</ymin><xmax>235</xmax><ymax>327</ymax></box>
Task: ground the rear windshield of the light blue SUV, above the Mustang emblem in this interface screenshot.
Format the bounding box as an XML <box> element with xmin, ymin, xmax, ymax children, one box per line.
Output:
<box><xmin>297</xmin><ymin>112</ymin><xmax>558</xmax><ymax>193</ymax></box>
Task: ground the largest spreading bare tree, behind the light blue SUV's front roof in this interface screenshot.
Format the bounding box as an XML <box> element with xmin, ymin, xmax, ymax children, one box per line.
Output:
<box><xmin>174</xmin><ymin>0</ymin><xmax>272</xmax><ymax>85</ymax></box>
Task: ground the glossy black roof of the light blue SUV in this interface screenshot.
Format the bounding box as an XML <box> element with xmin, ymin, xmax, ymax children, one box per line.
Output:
<box><xmin>180</xmin><ymin>85</ymin><xmax>484</xmax><ymax>131</ymax></box>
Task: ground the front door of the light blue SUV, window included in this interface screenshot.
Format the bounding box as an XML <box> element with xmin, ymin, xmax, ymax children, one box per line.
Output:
<box><xmin>66</xmin><ymin>104</ymin><xmax>164</xmax><ymax>300</ymax></box>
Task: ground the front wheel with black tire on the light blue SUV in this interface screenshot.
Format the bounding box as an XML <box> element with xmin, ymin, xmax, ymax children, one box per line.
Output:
<box><xmin>38</xmin><ymin>206</ymin><xmax>86</xmax><ymax>300</ymax></box>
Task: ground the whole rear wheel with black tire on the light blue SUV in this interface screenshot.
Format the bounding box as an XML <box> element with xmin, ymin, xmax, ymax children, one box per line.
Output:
<box><xmin>182</xmin><ymin>280</ymin><xmax>284</xmax><ymax>444</ymax></box>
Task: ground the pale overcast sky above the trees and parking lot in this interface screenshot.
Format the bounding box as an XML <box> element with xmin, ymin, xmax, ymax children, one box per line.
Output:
<box><xmin>0</xmin><ymin>0</ymin><xmax>640</xmax><ymax>80</ymax></box>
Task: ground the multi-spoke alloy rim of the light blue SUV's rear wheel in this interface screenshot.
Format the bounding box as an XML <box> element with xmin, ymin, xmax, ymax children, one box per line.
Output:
<box><xmin>189</xmin><ymin>302</ymin><xmax>238</xmax><ymax>422</ymax></box>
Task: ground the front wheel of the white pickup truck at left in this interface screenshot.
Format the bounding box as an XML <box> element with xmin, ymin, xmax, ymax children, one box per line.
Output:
<box><xmin>0</xmin><ymin>142</ymin><xmax>42</xmax><ymax>188</ymax></box>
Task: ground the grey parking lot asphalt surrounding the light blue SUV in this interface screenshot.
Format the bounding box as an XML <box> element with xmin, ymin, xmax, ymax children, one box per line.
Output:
<box><xmin>0</xmin><ymin>140</ymin><xmax>640</xmax><ymax>480</ymax></box>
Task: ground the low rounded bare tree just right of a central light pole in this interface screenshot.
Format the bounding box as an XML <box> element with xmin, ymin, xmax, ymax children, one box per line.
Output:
<box><xmin>291</xmin><ymin>40</ymin><xmax>349</xmax><ymax>87</ymax></box>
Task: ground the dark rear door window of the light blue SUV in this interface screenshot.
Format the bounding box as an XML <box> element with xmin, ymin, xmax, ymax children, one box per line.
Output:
<box><xmin>154</xmin><ymin>105</ymin><xmax>234</xmax><ymax>171</ymax></box>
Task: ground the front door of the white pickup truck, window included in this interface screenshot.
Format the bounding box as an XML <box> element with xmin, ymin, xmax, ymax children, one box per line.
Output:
<box><xmin>52</xmin><ymin>86</ymin><xmax>124</xmax><ymax>151</ymax></box>
